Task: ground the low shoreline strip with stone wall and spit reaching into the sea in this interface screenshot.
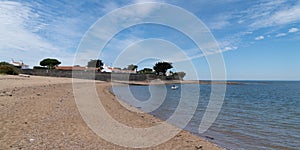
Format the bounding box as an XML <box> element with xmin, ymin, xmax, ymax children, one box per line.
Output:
<box><xmin>19</xmin><ymin>69</ymin><xmax>243</xmax><ymax>86</ymax></box>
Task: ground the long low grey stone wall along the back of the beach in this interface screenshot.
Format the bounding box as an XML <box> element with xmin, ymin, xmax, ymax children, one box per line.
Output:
<box><xmin>23</xmin><ymin>69</ymin><xmax>157</xmax><ymax>81</ymax></box>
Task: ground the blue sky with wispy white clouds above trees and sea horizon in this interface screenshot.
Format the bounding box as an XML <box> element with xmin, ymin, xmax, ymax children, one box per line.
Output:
<box><xmin>0</xmin><ymin>0</ymin><xmax>300</xmax><ymax>80</ymax></box>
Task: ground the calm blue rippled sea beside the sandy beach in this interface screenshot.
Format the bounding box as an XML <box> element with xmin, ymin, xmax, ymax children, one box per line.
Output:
<box><xmin>112</xmin><ymin>81</ymin><xmax>300</xmax><ymax>149</ymax></box>
